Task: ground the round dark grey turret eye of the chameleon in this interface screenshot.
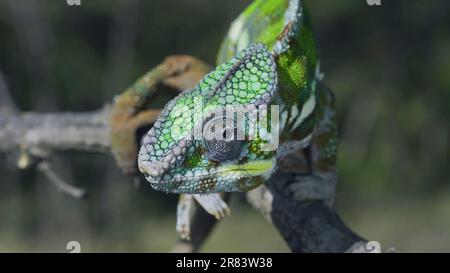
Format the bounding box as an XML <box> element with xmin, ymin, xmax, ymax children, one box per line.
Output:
<box><xmin>203</xmin><ymin>113</ymin><xmax>243</xmax><ymax>162</ymax></box>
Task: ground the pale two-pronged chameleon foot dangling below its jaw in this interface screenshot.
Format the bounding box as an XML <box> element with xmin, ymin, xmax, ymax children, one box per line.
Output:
<box><xmin>176</xmin><ymin>193</ymin><xmax>230</xmax><ymax>240</ymax></box>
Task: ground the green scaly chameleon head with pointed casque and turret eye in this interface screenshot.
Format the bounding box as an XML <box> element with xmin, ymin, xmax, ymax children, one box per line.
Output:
<box><xmin>138</xmin><ymin>44</ymin><xmax>277</xmax><ymax>193</ymax></box>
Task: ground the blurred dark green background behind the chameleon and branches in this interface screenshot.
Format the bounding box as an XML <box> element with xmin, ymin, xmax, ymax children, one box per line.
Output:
<box><xmin>0</xmin><ymin>0</ymin><xmax>450</xmax><ymax>252</ymax></box>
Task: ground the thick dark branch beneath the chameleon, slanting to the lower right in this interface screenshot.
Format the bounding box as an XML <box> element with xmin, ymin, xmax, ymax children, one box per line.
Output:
<box><xmin>267</xmin><ymin>173</ymin><xmax>365</xmax><ymax>252</ymax></box>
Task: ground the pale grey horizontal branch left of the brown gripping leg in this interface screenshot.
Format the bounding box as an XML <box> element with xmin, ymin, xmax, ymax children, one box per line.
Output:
<box><xmin>0</xmin><ymin>107</ymin><xmax>110</xmax><ymax>155</ymax></box>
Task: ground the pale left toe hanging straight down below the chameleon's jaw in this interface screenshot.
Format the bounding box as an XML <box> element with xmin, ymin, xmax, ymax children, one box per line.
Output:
<box><xmin>176</xmin><ymin>194</ymin><xmax>194</xmax><ymax>240</ymax></box>
